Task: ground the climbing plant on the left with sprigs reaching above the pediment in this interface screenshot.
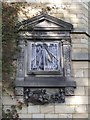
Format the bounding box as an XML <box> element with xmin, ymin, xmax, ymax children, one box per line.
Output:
<box><xmin>2</xmin><ymin>2</ymin><xmax>51</xmax><ymax>89</ymax></box>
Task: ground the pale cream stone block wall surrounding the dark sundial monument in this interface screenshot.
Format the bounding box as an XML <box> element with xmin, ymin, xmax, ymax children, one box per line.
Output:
<box><xmin>3</xmin><ymin>2</ymin><xmax>90</xmax><ymax>118</ymax></box>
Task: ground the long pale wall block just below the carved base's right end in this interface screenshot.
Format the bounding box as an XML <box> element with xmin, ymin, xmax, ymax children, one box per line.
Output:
<box><xmin>55</xmin><ymin>105</ymin><xmax>75</xmax><ymax>113</ymax></box>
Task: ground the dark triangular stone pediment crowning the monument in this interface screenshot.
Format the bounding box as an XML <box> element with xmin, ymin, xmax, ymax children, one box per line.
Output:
<box><xmin>17</xmin><ymin>14</ymin><xmax>73</xmax><ymax>31</ymax></box>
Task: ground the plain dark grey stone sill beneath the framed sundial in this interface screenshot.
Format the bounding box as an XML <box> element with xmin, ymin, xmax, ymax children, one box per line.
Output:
<box><xmin>15</xmin><ymin>76</ymin><xmax>76</xmax><ymax>88</ymax></box>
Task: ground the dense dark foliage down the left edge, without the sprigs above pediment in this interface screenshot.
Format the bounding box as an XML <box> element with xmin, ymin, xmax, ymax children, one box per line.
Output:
<box><xmin>2</xmin><ymin>2</ymin><xmax>22</xmax><ymax>89</ymax></box>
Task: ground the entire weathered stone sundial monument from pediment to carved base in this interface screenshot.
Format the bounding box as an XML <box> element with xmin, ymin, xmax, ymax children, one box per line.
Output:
<box><xmin>15</xmin><ymin>14</ymin><xmax>76</xmax><ymax>104</ymax></box>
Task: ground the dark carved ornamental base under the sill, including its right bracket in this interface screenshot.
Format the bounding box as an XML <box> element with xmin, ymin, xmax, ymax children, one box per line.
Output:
<box><xmin>24</xmin><ymin>87</ymin><xmax>74</xmax><ymax>105</ymax></box>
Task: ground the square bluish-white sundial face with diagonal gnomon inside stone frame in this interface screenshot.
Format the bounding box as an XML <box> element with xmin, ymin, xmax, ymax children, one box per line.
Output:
<box><xmin>29</xmin><ymin>42</ymin><xmax>60</xmax><ymax>71</ymax></box>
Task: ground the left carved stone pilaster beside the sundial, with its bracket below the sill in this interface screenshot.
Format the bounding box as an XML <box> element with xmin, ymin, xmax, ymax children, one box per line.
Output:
<box><xmin>15</xmin><ymin>40</ymin><xmax>25</xmax><ymax>96</ymax></box>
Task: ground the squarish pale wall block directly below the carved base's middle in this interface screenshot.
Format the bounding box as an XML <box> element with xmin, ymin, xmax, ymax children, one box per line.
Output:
<box><xmin>41</xmin><ymin>105</ymin><xmax>54</xmax><ymax>113</ymax></box>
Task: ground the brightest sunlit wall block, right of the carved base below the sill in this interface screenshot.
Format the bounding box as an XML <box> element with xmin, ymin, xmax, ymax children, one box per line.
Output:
<box><xmin>66</xmin><ymin>96</ymin><xmax>88</xmax><ymax>105</ymax></box>
